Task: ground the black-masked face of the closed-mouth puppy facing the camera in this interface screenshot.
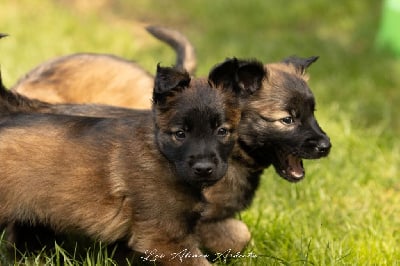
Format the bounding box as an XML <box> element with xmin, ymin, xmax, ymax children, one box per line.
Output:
<box><xmin>153</xmin><ymin>77</ymin><xmax>240</xmax><ymax>187</ymax></box>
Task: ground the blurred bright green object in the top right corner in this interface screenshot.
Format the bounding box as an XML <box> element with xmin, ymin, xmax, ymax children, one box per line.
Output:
<box><xmin>377</xmin><ymin>0</ymin><xmax>400</xmax><ymax>56</ymax></box>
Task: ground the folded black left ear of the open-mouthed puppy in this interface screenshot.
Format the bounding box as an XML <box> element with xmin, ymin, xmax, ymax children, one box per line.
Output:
<box><xmin>208</xmin><ymin>58</ymin><xmax>266</xmax><ymax>96</ymax></box>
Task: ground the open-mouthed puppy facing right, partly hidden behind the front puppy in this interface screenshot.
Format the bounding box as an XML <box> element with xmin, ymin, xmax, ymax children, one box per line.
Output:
<box><xmin>2</xmin><ymin>57</ymin><xmax>331</xmax><ymax>252</ymax></box>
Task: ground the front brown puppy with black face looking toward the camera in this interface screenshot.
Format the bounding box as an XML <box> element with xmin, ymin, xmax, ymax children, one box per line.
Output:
<box><xmin>0</xmin><ymin>63</ymin><xmax>244</xmax><ymax>265</ymax></box>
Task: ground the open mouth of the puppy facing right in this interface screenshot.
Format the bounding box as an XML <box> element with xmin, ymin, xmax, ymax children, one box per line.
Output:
<box><xmin>275</xmin><ymin>152</ymin><xmax>305</xmax><ymax>182</ymax></box>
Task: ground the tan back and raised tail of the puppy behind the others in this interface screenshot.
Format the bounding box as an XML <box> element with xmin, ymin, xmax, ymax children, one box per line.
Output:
<box><xmin>12</xmin><ymin>26</ymin><xmax>196</xmax><ymax>109</ymax></box>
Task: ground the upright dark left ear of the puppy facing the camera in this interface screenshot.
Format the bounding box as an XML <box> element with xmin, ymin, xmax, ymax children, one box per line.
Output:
<box><xmin>153</xmin><ymin>64</ymin><xmax>190</xmax><ymax>103</ymax></box>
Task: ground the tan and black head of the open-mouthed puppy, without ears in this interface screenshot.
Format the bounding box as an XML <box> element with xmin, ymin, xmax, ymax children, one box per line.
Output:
<box><xmin>239</xmin><ymin>57</ymin><xmax>331</xmax><ymax>182</ymax></box>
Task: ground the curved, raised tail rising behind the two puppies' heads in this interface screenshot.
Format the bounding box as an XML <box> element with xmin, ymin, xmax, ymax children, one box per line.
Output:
<box><xmin>146</xmin><ymin>25</ymin><xmax>197</xmax><ymax>75</ymax></box>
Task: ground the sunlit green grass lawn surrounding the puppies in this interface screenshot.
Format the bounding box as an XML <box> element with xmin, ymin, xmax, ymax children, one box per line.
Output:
<box><xmin>0</xmin><ymin>0</ymin><xmax>400</xmax><ymax>265</ymax></box>
